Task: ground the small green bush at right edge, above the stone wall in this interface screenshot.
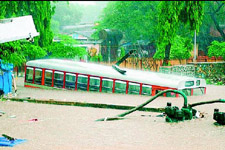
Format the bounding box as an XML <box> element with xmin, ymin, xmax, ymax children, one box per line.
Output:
<box><xmin>208</xmin><ymin>41</ymin><xmax>225</xmax><ymax>60</ymax></box>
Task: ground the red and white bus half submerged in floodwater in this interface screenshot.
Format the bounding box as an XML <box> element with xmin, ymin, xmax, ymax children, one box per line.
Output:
<box><xmin>24</xmin><ymin>59</ymin><xmax>206</xmax><ymax>97</ymax></box>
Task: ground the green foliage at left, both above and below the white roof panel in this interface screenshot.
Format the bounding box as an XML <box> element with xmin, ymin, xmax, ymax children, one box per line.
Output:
<box><xmin>0</xmin><ymin>1</ymin><xmax>54</xmax><ymax>66</ymax></box>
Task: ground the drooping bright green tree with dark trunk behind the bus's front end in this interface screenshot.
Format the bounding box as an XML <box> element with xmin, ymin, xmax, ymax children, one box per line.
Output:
<box><xmin>157</xmin><ymin>1</ymin><xmax>204</xmax><ymax>65</ymax></box>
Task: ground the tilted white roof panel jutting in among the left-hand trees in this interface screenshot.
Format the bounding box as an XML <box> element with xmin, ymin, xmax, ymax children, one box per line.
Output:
<box><xmin>0</xmin><ymin>15</ymin><xmax>39</xmax><ymax>43</ymax></box>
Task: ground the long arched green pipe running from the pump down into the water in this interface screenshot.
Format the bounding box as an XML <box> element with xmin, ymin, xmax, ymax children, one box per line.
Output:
<box><xmin>96</xmin><ymin>89</ymin><xmax>188</xmax><ymax>121</ymax></box>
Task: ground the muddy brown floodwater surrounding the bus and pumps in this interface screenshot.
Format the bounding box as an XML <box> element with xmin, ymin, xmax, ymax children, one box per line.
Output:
<box><xmin>0</xmin><ymin>78</ymin><xmax>225</xmax><ymax>150</ymax></box>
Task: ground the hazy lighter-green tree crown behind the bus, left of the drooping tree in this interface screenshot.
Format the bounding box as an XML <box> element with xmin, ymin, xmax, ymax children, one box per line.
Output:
<box><xmin>92</xmin><ymin>1</ymin><xmax>158</xmax><ymax>42</ymax></box>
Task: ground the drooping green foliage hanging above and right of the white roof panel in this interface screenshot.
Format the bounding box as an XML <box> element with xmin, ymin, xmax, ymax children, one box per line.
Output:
<box><xmin>0</xmin><ymin>1</ymin><xmax>54</xmax><ymax>47</ymax></box>
